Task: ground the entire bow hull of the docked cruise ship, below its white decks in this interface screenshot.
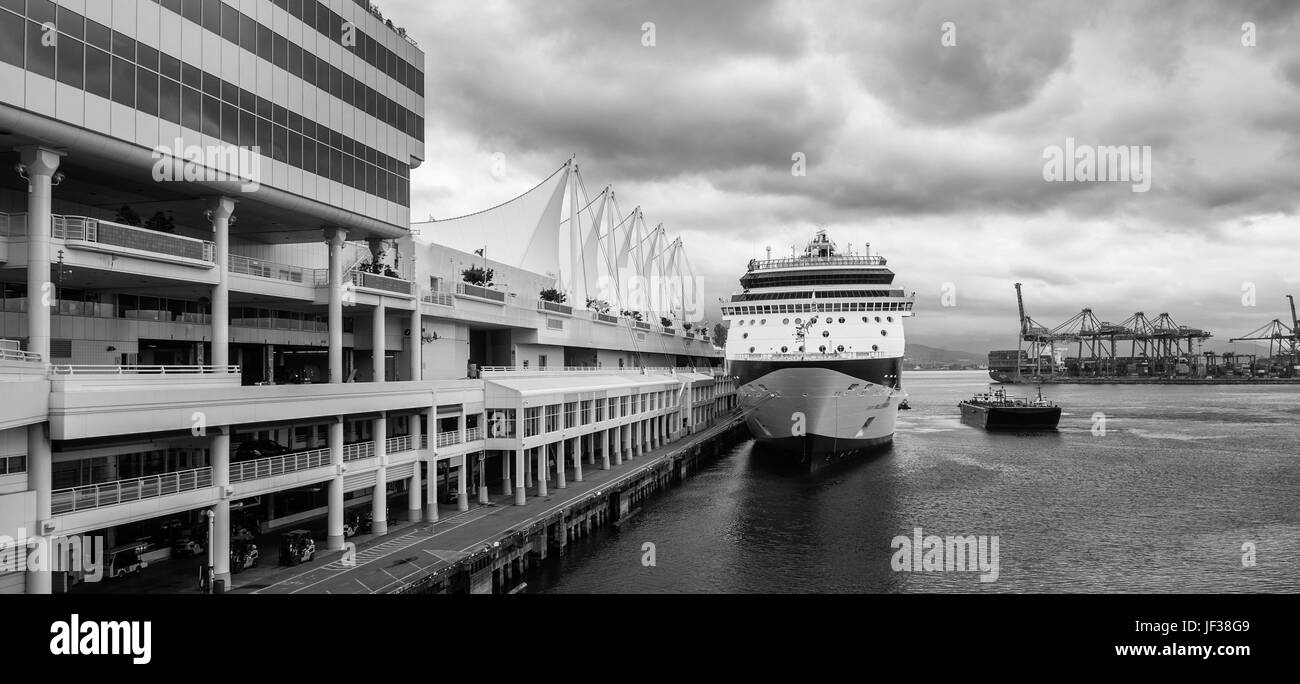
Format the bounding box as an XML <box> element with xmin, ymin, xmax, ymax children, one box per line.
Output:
<box><xmin>732</xmin><ymin>359</ymin><xmax>905</xmax><ymax>456</ymax></box>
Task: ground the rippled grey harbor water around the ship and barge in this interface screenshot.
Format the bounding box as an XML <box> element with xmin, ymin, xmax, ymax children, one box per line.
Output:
<box><xmin>528</xmin><ymin>372</ymin><xmax>1300</xmax><ymax>593</ymax></box>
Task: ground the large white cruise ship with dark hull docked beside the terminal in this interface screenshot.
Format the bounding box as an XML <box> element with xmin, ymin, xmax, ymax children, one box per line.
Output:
<box><xmin>723</xmin><ymin>230</ymin><xmax>915</xmax><ymax>459</ymax></box>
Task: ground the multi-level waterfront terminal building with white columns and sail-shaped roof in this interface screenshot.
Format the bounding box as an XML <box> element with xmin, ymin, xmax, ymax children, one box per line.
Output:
<box><xmin>0</xmin><ymin>0</ymin><xmax>736</xmax><ymax>593</ymax></box>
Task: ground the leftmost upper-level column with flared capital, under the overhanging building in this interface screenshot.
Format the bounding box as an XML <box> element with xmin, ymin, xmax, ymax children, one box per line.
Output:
<box><xmin>17</xmin><ymin>146</ymin><xmax>64</xmax><ymax>366</ymax></box>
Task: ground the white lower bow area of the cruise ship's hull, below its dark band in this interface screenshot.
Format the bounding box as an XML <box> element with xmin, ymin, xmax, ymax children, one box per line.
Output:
<box><xmin>746</xmin><ymin>368</ymin><xmax>904</xmax><ymax>451</ymax></box>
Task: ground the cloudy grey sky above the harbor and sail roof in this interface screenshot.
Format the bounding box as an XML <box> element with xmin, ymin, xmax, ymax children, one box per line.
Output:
<box><xmin>381</xmin><ymin>0</ymin><xmax>1300</xmax><ymax>352</ymax></box>
